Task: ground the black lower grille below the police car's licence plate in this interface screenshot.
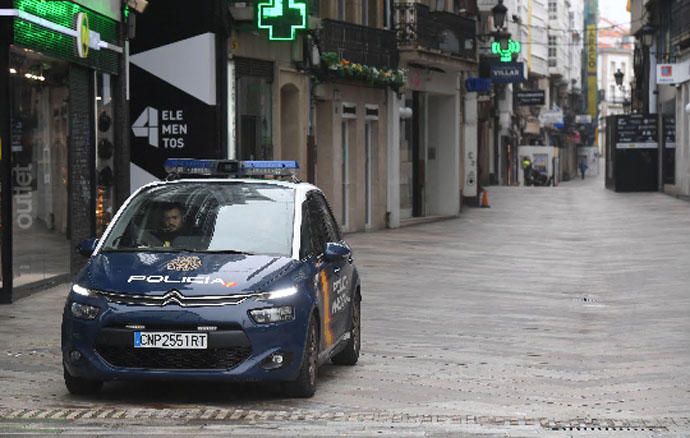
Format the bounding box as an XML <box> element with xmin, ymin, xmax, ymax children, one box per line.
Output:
<box><xmin>96</xmin><ymin>345</ymin><xmax>252</xmax><ymax>370</ymax></box>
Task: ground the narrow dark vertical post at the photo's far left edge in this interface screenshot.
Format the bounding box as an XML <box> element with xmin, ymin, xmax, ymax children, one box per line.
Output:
<box><xmin>0</xmin><ymin>8</ymin><xmax>13</xmax><ymax>304</ymax></box>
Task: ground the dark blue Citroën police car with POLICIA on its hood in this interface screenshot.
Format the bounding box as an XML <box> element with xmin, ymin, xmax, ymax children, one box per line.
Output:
<box><xmin>62</xmin><ymin>160</ymin><xmax>361</xmax><ymax>397</ymax></box>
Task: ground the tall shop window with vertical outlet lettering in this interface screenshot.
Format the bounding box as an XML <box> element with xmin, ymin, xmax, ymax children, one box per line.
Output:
<box><xmin>10</xmin><ymin>50</ymin><xmax>70</xmax><ymax>287</ymax></box>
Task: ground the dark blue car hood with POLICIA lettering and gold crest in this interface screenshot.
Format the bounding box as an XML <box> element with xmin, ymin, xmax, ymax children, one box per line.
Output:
<box><xmin>82</xmin><ymin>252</ymin><xmax>298</xmax><ymax>296</ymax></box>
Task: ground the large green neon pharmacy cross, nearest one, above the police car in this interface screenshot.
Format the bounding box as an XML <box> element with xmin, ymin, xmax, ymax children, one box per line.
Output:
<box><xmin>256</xmin><ymin>0</ymin><xmax>308</xmax><ymax>41</ymax></box>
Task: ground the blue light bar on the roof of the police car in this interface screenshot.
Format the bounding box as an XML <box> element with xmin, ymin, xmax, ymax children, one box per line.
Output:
<box><xmin>165</xmin><ymin>158</ymin><xmax>299</xmax><ymax>178</ymax></box>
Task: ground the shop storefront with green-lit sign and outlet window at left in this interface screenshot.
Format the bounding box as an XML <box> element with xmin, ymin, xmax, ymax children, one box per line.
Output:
<box><xmin>0</xmin><ymin>0</ymin><xmax>123</xmax><ymax>302</ymax></box>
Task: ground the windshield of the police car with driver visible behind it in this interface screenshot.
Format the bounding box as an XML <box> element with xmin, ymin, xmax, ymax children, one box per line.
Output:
<box><xmin>101</xmin><ymin>182</ymin><xmax>295</xmax><ymax>257</ymax></box>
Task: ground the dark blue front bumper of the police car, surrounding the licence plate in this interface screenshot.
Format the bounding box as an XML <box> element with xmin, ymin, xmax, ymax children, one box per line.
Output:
<box><xmin>62</xmin><ymin>294</ymin><xmax>311</xmax><ymax>381</ymax></box>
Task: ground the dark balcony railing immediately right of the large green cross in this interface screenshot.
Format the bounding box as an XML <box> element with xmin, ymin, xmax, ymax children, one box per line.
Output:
<box><xmin>320</xmin><ymin>19</ymin><xmax>398</xmax><ymax>69</ymax></box>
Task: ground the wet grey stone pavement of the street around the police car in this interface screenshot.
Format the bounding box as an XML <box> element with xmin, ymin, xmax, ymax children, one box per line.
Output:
<box><xmin>0</xmin><ymin>175</ymin><xmax>690</xmax><ymax>437</ymax></box>
